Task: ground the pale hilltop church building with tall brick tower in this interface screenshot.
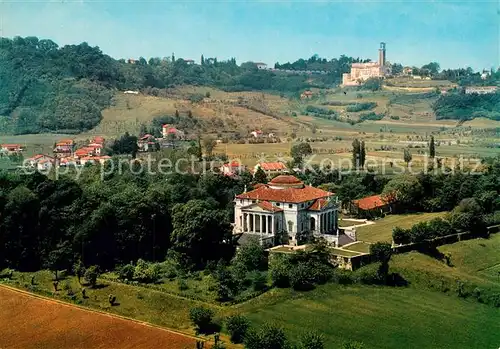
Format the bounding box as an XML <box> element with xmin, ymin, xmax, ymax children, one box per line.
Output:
<box><xmin>342</xmin><ymin>42</ymin><xmax>390</xmax><ymax>86</ymax></box>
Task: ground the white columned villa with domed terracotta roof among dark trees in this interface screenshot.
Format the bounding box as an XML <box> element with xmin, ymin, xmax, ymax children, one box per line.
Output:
<box><xmin>234</xmin><ymin>175</ymin><xmax>344</xmax><ymax>246</ymax></box>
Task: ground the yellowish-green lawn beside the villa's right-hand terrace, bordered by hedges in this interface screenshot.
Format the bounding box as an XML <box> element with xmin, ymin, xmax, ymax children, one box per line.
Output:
<box><xmin>356</xmin><ymin>212</ymin><xmax>446</xmax><ymax>242</ymax></box>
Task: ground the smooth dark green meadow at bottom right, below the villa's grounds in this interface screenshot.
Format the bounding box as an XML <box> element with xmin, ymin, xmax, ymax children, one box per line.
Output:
<box><xmin>239</xmin><ymin>284</ymin><xmax>500</xmax><ymax>349</ymax></box>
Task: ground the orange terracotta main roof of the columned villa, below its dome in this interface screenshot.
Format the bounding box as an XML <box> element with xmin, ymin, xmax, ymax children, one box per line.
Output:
<box><xmin>236</xmin><ymin>185</ymin><xmax>333</xmax><ymax>203</ymax></box>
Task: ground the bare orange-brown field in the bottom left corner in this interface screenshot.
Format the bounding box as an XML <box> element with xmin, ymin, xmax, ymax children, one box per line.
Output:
<box><xmin>0</xmin><ymin>285</ymin><xmax>203</xmax><ymax>349</ymax></box>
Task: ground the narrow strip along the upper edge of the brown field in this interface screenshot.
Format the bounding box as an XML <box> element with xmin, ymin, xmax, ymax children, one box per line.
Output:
<box><xmin>0</xmin><ymin>283</ymin><xmax>210</xmax><ymax>342</ymax></box>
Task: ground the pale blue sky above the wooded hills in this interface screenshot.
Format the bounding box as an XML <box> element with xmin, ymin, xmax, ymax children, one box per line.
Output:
<box><xmin>0</xmin><ymin>0</ymin><xmax>500</xmax><ymax>70</ymax></box>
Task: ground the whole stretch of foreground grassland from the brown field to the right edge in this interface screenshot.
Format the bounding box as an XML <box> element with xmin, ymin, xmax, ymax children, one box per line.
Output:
<box><xmin>3</xmin><ymin>234</ymin><xmax>500</xmax><ymax>349</ymax></box>
